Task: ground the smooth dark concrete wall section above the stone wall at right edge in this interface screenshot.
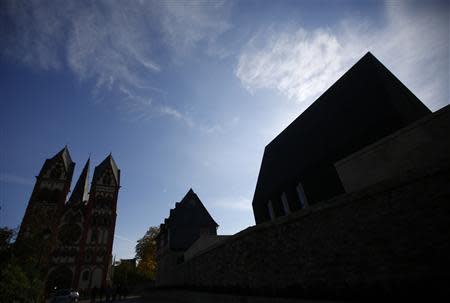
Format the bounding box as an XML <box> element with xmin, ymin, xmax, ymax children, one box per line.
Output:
<box><xmin>335</xmin><ymin>105</ymin><xmax>450</xmax><ymax>192</ymax></box>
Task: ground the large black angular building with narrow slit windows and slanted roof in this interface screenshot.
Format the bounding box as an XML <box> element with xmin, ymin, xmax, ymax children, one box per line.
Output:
<box><xmin>252</xmin><ymin>53</ymin><xmax>431</xmax><ymax>224</ymax></box>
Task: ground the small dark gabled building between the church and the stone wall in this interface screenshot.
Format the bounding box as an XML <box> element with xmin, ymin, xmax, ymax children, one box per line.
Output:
<box><xmin>156</xmin><ymin>189</ymin><xmax>219</xmax><ymax>284</ymax></box>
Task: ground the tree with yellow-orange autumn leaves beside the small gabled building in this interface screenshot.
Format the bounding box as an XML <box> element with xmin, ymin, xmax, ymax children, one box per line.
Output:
<box><xmin>136</xmin><ymin>226</ymin><xmax>159</xmax><ymax>280</ymax></box>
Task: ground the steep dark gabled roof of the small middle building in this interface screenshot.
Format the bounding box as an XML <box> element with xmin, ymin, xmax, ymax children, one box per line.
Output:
<box><xmin>164</xmin><ymin>188</ymin><xmax>219</xmax><ymax>227</ymax></box>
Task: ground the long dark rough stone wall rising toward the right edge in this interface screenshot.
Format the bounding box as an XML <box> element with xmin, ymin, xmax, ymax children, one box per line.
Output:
<box><xmin>160</xmin><ymin>168</ymin><xmax>450</xmax><ymax>298</ymax></box>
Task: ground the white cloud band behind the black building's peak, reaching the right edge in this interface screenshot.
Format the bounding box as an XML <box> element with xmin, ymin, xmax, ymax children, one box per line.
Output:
<box><xmin>235</xmin><ymin>1</ymin><xmax>449</xmax><ymax>109</ymax></box>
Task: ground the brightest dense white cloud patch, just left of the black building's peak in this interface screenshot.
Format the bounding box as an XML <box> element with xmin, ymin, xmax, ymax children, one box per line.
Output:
<box><xmin>236</xmin><ymin>28</ymin><xmax>342</xmax><ymax>107</ymax></box>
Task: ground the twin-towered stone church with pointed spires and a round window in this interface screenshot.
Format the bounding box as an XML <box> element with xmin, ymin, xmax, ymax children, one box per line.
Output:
<box><xmin>17</xmin><ymin>146</ymin><xmax>120</xmax><ymax>291</ymax></box>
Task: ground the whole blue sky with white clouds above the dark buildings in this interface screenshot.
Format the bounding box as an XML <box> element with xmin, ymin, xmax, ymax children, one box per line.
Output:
<box><xmin>0</xmin><ymin>0</ymin><xmax>450</xmax><ymax>259</ymax></box>
